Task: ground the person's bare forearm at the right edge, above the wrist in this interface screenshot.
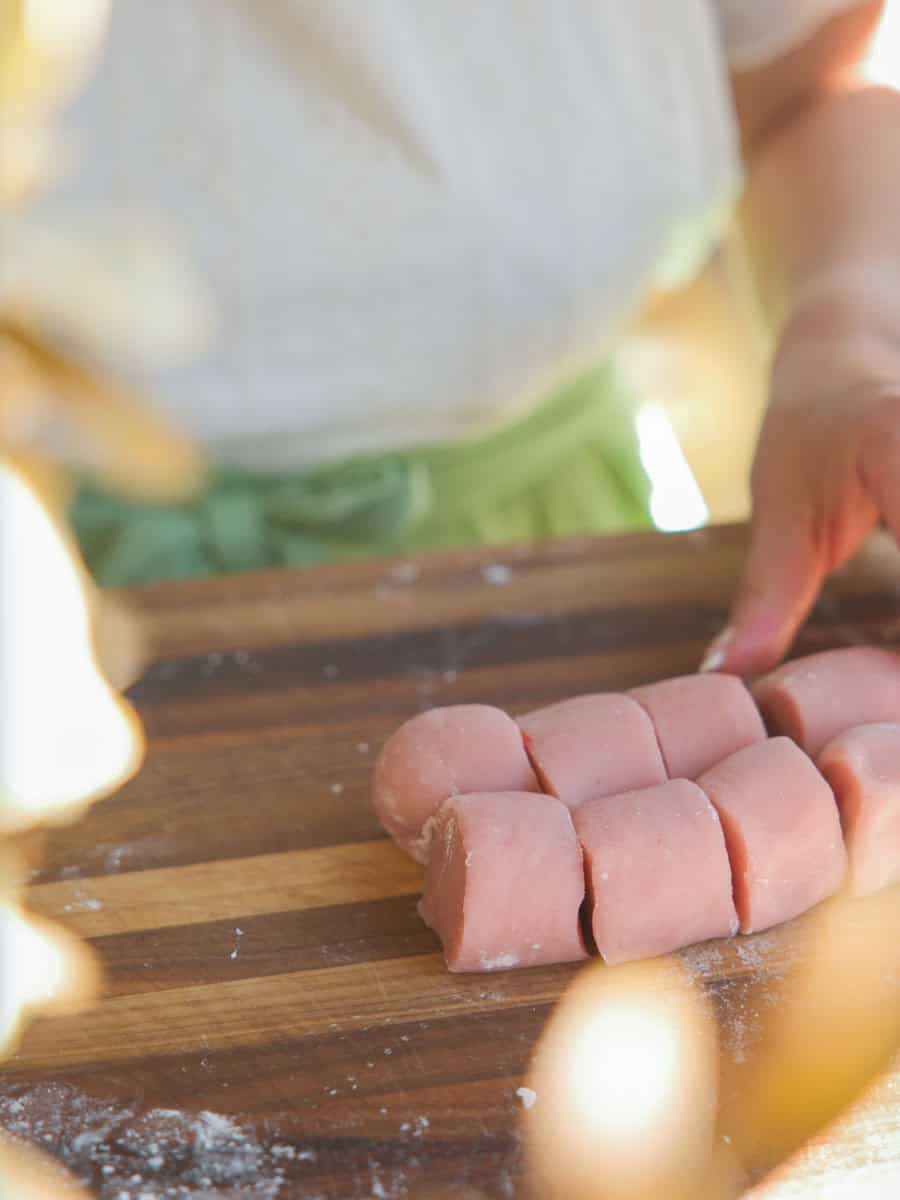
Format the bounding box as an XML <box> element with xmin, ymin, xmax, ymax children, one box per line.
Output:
<box><xmin>742</xmin><ymin>86</ymin><xmax>900</xmax><ymax>350</ymax></box>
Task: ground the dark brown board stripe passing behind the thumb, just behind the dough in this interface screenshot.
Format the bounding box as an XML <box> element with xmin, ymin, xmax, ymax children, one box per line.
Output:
<box><xmin>128</xmin><ymin>594</ymin><xmax>900</xmax><ymax>737</ymax></box>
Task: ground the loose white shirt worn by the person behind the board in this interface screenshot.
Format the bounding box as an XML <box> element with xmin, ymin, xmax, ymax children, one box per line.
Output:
<box><xmin>33</xmin><ymin>0</ymin><xmax>858</xmax><ymax>467</ymax></box>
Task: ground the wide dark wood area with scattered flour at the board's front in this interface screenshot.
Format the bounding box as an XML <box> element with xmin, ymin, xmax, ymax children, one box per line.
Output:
<box><xmin>0</xmin><ymin>1008</ymin><xmax>550</xmax><ymax>1200</ymax></box>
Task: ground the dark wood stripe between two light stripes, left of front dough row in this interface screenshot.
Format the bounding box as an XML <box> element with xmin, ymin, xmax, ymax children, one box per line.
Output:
<box><xmin>91</xmin><ymin>896</ymin><xmax>440</xmax><ymax>996</ymax></box>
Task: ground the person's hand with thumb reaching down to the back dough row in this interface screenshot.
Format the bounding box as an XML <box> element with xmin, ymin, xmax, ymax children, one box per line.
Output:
<box><xmin>701</xmin><ymin>280</ymin><xmax>900</xmax><ymax>676</ymax></box>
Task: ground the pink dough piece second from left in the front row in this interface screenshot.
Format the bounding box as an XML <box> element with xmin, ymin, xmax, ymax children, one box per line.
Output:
<box><xmin>574</xmin><ymin>779</ymin><xmax>738</xmax><ymax>964</ymax></box>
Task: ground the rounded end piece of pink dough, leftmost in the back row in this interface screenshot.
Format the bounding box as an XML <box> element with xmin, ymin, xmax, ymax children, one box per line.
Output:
<box><xmin>373</xmin><ymin>704</ymin><xmax>540</xmax><ymax>863</ymax></box>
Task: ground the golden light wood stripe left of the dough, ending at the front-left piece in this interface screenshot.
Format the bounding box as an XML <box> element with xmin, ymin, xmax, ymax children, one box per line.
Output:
<box><xmin>28</xmin><ymin>844</ymin><xmax>422</xmax><ymax>937</ymax></box>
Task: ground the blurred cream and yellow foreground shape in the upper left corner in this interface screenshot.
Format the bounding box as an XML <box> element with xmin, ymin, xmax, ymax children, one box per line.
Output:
<box><xmin>0</xmin><ymin>0</ymin><xmax>210</xmax><ymax>499</ymax></box>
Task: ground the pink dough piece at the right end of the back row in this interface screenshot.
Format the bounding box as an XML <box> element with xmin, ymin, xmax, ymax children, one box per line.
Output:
<box><xmin>752</xmin><ymin>646</ymin><xmax>900</xmax><ymax>758</ymax></box>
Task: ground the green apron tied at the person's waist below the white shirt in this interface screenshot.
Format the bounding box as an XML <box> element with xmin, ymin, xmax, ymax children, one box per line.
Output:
<box><xmin>71</xmin><ymin>352</ymin><xmax>652</xmax><ymax>587</ymax></box>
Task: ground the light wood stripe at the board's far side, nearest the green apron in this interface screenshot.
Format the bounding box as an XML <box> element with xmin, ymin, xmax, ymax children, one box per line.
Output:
<box><xmin>128</xmin><ymin>540</ymin><xmax>744</xmax><ymax>656</ymax></box>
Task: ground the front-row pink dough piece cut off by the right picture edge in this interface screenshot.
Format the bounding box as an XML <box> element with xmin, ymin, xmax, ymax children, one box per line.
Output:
<box><xmin>818</xmin><ymin>724</ymin><xmax>900</xmax><ymax>896</ymax></box>
